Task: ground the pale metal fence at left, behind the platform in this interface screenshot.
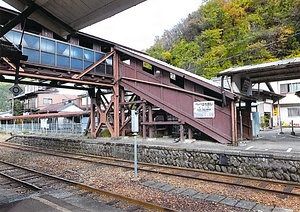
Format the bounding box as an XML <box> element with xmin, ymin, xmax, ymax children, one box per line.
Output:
<box><xmin>0</xmin><ymin>123</ymin><xmax>85</xmax><ymax>135</ymax></box>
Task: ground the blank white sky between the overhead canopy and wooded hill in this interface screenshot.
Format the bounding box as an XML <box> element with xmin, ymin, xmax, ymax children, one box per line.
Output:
<box><xmin>0</xmin><ymin>0</ymin><xmax>202</xmax><ymax>50</ymax></box>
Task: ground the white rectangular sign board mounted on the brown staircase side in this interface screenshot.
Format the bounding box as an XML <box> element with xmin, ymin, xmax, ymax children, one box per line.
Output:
<box><xmin>194</xmin><ymin>101</ymin><xmax>215</xmax><ymax>118</ymax></box>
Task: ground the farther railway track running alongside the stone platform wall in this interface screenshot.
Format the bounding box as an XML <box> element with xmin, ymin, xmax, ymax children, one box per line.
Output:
<box><xmin>0</xmin><ymin>142</ymin><xmax>300</xmax><ymax>198</ymax></box>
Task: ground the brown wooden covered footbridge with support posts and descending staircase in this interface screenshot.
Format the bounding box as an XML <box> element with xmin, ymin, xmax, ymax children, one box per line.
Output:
<box><xmin>0</xmin><ymin>2</ymin><xmax>248</xmax><ymax>144</ymax></box>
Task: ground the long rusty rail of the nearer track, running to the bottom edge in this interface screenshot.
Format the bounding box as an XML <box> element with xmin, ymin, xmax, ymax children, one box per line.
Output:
<box><xmin>0</xmin><ymin>160</ymin><xmax>175</xmax><ymax>212</ymax></box>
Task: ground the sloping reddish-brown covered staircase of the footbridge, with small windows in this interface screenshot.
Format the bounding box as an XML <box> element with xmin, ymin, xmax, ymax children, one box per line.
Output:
<box><xmin>117</xmin><ymin>47</ymin><xmax>235</xmax><ymax>143</ymax></box>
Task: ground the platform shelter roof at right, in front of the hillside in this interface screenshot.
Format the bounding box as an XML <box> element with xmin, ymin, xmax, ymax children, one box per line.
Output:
<box><xmin>218</xmin><ymin>58</ymin><xmax>300</xmax><ymax>83</ymax></box>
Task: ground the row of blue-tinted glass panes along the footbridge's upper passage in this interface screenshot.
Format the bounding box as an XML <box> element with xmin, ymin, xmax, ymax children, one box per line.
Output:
<box><xmin>5</xmin><ymin>30</ymin><xmax>113</xmax><ymax>76</ymax></box>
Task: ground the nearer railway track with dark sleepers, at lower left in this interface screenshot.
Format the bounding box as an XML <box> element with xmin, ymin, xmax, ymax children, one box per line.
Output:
<box><xmin>0</xmin><ymin>157</ymin><xmax>174</xmax><ymax>211</ymax></box>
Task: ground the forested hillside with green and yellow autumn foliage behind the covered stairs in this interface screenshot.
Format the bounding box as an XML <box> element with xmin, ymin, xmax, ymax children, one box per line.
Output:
<box><xmin>147</xmin><ymin>0</ymin><xmax>300</xmax><ymax>78</ymax></box>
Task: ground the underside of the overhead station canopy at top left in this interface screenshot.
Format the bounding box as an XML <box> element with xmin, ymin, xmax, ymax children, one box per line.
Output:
<box><xmin>4</xmin><ymin>0</ymin><xmax>145</xmax><ymax>36</ymax></box>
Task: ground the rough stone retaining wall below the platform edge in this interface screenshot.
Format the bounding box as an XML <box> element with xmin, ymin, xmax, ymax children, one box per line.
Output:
<box><xmin>7</xmin><ymin>136</ymin><xmax>300</xmax><ymax>182</ymax></box>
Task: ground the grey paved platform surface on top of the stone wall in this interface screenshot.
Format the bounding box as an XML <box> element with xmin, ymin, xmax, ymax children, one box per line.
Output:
<box><xmin>115</xmin><ymin>128</ymin><xmax>300</xmax><ymax>156</ymax></box>
